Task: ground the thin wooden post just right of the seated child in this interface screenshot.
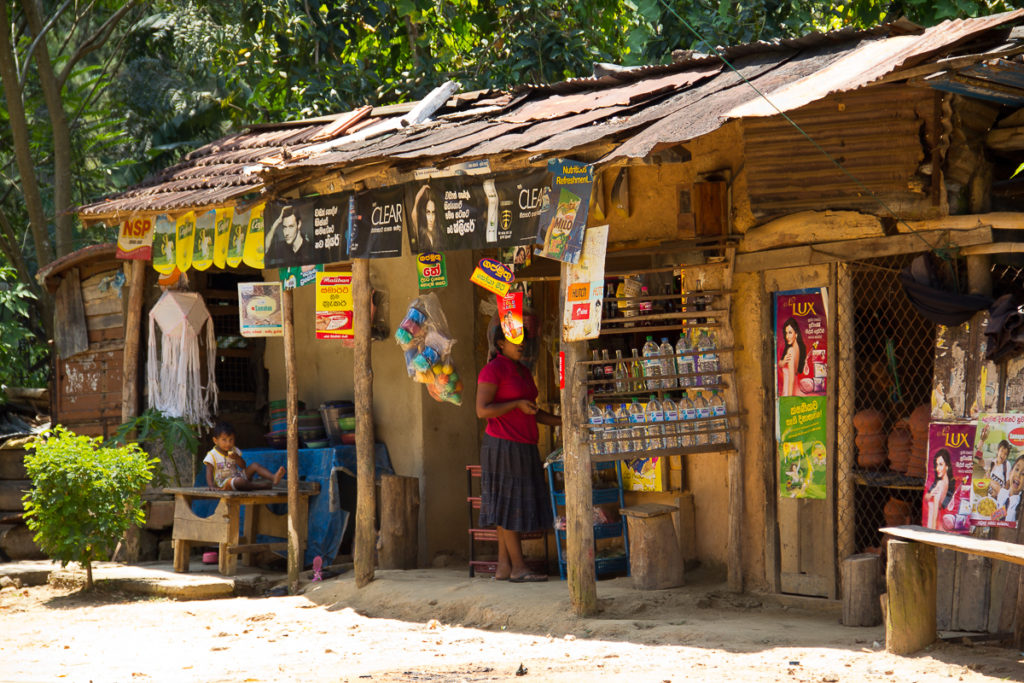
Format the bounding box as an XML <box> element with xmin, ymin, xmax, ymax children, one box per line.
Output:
<box><xmin>280</xmin><ymin>290</ymin><xmax>302</xmax><ymax>595</ymax></box>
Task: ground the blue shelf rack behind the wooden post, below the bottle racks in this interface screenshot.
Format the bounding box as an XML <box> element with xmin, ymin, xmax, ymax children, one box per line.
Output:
<box><xmin>547</xmin><ymin>460</ymin><xmax>630</xmax><ymax>580</ymax></box>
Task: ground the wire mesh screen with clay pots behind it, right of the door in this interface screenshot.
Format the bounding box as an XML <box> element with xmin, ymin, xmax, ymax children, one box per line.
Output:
<box><xmin>837</xmin><ymin>255</ymin><xmax>935</xmax><ymax>560</ymax></box>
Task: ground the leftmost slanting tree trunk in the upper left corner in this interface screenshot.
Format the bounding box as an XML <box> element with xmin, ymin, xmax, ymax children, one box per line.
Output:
<box><xmin>0</xmin><ymin>2</ymin><xmax>53</xmax><ymax>265</ymax></box>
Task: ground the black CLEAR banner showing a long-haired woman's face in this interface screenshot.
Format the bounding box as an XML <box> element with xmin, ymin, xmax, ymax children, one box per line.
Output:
<box><xmin>404</xmin><ymin>171</ymin><xmax>551</xmax><ymax>253</ymax></box>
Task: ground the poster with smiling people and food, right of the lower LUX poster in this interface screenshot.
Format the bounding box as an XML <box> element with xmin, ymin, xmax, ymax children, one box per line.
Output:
<box><xmin>971</xmin><ymin>413</ymin><xmax>1024</xmax><ymax>528</ymax></box>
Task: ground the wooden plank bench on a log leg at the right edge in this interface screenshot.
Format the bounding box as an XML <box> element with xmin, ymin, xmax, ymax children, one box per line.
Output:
<box><xmin>881</xmin><ymin>524</ymin><xmax>1024</xmax><ymax>654</ymax></box>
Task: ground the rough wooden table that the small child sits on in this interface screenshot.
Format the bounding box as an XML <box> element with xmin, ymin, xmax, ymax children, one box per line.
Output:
<box><xmin>164</xmin><ymin>481</ymin><xmax>319</xmax><ymax>577</ymax></box>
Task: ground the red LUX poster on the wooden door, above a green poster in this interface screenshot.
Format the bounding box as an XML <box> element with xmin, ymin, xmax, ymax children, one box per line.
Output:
<box><xmin>775</xmin><ymin>289</ymin><xmax>828</xmax><ymax>396</ymax></box>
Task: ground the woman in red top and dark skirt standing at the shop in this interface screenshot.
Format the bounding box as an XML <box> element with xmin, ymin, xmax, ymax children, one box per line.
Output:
<box><xmin>476</xmin><ymin>325</ymin><xmax>562</xmax><ymax>583</ymax></box>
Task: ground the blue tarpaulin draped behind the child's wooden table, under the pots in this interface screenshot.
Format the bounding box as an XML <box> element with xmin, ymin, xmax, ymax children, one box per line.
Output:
<box><xmin>193</xmin><ymin>443</ymin><xmax>394</xmax><ymax>566</ymax></box>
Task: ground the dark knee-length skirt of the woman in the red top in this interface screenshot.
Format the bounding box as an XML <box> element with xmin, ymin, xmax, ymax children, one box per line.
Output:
<box><xmin>479</xmin><ymin>434</ymin><xmax>552</xmax><ymax>531</ymax></box>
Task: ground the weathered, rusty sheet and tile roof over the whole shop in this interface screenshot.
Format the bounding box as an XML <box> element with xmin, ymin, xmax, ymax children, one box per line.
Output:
<box><xmin>80</xmin><ymin>10</ymin><xmax>1024</xmax><ymax>219</ymax></box>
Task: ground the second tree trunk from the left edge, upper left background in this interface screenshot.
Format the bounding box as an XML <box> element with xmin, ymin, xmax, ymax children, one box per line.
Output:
<box><xmin>22</xmin><ymin>0</ymin><xmax>74</xmax><ymax>258</ymax></box>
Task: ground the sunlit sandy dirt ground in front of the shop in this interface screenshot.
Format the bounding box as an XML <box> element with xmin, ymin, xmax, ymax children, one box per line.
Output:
<box><xmin>0</xmin><ymin>570</ymin><xmax>1024</xmax><ymax>682</ymax></box>
